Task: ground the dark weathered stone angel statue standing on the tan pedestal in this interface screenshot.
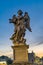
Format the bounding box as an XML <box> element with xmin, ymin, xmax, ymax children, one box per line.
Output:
<box><xmin>9</xmin><ymin>10</ymin><xmax>32</xmax><ymax>44</ymax></box>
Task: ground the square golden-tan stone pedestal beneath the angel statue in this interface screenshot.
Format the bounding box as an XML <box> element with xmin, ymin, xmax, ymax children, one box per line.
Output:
<box><xmin>12</xmin><ymin>44</ymin><xmax>29</xmax><ymax>65</ymax></box>
